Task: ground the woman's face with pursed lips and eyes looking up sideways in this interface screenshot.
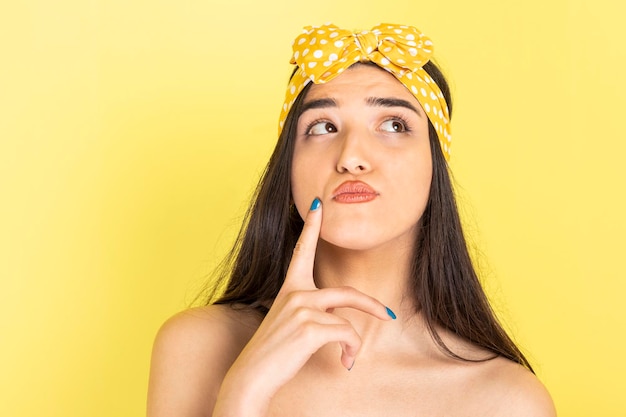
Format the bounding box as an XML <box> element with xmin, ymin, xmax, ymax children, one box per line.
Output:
<box><xmin>291</xmin><ymin>65</ymin><xmax>432</xmax><ymax>250</ymax></box>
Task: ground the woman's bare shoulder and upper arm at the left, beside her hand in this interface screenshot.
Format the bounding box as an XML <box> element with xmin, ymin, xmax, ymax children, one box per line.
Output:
<box><xmin>148</xmin><ymin>305</ymin><xmax>260</xmax><ymax>417</ymax></box>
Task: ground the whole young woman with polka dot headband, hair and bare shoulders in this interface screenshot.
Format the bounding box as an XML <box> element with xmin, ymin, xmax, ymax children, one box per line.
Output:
<box><xmin>148</xmin><ymin>25</ymin><xmax>555</xmax><ymax>417</ymax></box>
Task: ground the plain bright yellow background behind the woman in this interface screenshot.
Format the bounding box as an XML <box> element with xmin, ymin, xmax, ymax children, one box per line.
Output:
<box><xmin>0</xmin><ymin>0</ymin><xmax>626</xmax><ymax>417</ymax></box>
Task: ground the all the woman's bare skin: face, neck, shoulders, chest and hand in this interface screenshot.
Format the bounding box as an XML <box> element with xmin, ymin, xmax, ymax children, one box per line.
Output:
<box><xmin>148</xmin><ymin>66</ymin><xmax>555</xmax><ymax>417</ymax></box>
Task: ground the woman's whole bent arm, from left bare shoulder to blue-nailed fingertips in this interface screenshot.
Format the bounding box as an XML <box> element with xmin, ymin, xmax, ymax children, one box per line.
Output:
<box><xmin>148</xmin><ymin>201</ymin><xmax>391</xmax><ymax>417</ymax></box>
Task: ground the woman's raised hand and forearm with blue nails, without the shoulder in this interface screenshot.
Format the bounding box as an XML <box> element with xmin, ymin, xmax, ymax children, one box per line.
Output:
<box><xmin>213</xmin><ymin>199</ymin><xmax>391</xmax><ymax>416</ymax></box>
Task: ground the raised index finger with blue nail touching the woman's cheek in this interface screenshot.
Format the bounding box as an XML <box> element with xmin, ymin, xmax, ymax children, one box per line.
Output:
<box><xmin>283</xmin><ymin>197</ymin><xmax>322</xmax><ymax>289</ymax></box>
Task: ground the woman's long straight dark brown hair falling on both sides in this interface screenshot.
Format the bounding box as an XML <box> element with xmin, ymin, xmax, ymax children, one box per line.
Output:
<box><xmin>208</xmin><ymin>62</ymin><xmax>532</xmax><ymax>371</ymax></box>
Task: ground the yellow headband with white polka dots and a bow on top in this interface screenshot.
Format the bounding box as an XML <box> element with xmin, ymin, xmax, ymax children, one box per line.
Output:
<box><xmin>279</xmin><ymin>24</ymin><xmax>452</xmax><ymax>160</ymax></box>
